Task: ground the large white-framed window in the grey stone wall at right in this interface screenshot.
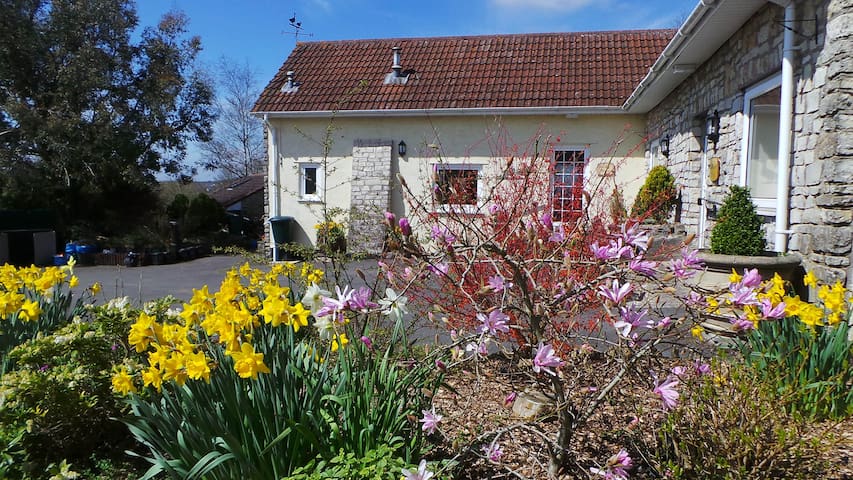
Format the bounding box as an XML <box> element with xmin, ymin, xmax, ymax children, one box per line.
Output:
<box><xmin>740</xmin><ymin>75</ymin><xmax>782</xmax><ymax>215</ymax></box>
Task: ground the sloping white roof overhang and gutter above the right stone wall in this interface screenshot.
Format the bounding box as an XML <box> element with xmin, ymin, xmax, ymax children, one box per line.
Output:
<box><xmin>622</xmin><ymin>0</ymin><xmax>778</xmax><ymax>113</ymax></box>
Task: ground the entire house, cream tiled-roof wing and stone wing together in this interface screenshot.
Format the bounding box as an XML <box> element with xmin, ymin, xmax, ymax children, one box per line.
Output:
<box><xmin>255</xmin><ymin>0</ymin><xmax>853</xmax><ymax>287</ymax></box>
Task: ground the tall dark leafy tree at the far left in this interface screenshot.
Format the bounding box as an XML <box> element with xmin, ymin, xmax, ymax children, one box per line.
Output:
<box><xmin>0</xmin><ymin>0</ymin><xmax>215</xmax><ymax>233</ymax></box>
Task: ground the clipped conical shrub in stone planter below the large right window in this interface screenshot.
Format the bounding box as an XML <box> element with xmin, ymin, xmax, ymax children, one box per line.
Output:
<box><xmin>699</xmin><ymin>186</ymin><xmax>802</xmax><ymax>290</ymax></box>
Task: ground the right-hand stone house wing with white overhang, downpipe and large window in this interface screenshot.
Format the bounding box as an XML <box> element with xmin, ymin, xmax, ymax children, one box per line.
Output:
<box><xmin>623</xmin><ymin>0</ymin><xmax>853</xmax><ymax>287</ymax></box>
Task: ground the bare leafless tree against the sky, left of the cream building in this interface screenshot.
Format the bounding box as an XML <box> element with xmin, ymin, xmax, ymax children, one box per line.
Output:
<box><xmin>201</xmin><ymin>58</ymin><xmax>266</xmax><ymax>178</ymax></box>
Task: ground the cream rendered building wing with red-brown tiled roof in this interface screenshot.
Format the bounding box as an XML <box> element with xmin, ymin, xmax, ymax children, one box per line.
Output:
<box><xmin>254</xmin><ymin>30</ymin><xmax>675</xmax><ymax>252</ymax></box>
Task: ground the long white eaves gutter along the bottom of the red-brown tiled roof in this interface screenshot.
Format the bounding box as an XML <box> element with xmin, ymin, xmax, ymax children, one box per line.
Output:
<box><xmin>252</xmin><ymin>106</ymin><xmax>624</xmax><ymax>118</ymax></box>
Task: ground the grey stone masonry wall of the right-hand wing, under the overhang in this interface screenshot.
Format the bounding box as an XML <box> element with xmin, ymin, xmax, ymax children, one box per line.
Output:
<box><xmin>648</xmin><ymin>0</ymin><xmax>853</xmax><ymax>285</ymax></box>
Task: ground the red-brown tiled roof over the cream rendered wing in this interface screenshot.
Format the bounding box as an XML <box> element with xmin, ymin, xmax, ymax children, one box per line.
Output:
<box><xmin>254</xmin><ymin>30</ymin><xmax>675</xmax><ymax>112</ymax></box>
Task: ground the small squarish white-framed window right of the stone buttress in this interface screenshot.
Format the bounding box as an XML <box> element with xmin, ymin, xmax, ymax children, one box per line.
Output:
<box><xmin>433</xmin><ymin>163</ymin><xmax>483</xmax><ymax>213</ymax></box>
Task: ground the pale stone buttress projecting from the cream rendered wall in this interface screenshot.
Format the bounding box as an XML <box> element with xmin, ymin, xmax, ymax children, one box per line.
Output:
<box><xmin>347</xmin><ymin>140</ymin><xmax>394</xmax><ymax>255</ymax></box>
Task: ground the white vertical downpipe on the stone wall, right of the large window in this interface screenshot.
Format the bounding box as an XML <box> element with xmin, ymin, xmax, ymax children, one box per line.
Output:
<box><xmin>773</xmin><ymin>2</ymin><xmax>796</xmax><ymax>253</ymax></box>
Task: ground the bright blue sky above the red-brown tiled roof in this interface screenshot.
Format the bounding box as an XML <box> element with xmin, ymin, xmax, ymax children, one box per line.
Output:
<box><xmin>137</xmin><ymin>0</ymin><xmax>698</xmax><ymax>91</ymax></box>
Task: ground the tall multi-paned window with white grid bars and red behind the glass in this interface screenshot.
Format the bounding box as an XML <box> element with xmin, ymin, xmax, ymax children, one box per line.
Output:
<box><xmin>551</xmin><ymin>150</ymin><xmax>586</xmax><ymax>222</ymax></box>
